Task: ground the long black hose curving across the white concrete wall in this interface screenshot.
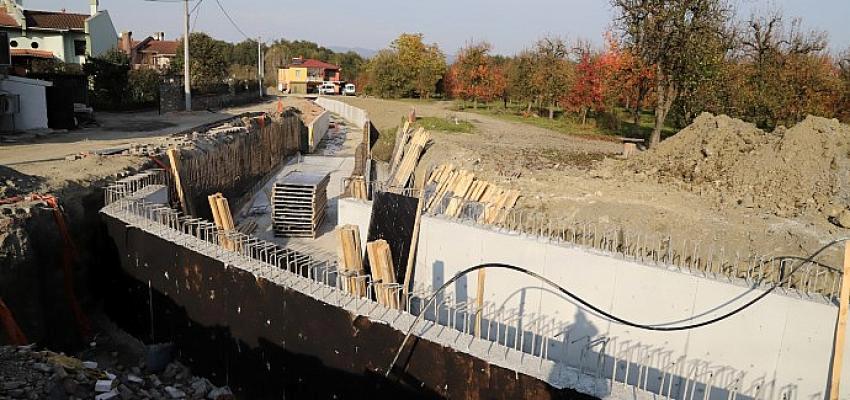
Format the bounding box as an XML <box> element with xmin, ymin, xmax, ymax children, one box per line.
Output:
<box><xmin>386</xmin><ymin>237</ymin><xmax>850</xmax><ymax>376</ymax></box>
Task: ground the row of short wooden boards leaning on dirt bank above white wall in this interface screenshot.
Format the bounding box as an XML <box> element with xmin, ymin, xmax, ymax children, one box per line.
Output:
<box><xmin>425</xmin><ymin>164</ymin><xmax>520</xmax><ymax>224</ymax></box>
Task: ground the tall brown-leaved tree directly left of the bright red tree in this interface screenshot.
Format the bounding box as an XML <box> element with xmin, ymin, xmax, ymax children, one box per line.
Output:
<box><xmin>530</xmin><ymin>36</ymin><xmax>572</xmax><ymax>119</ymax></box>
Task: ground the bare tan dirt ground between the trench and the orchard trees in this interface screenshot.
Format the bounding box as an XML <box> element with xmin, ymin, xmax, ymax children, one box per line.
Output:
<box><xmin>336</xmin><ymin>98</ymin><xmax>848</xmax><ymax>268</ymax></box>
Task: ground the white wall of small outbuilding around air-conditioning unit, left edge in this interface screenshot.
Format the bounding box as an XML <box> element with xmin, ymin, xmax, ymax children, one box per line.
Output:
<box><xmin>0</xmin><ymin>76</ymin><xmax>52</xmax><ymax>130</ymax></box>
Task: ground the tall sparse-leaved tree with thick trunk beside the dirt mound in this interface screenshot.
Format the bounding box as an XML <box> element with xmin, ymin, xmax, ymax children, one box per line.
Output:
<box><xmin>611</xmin><ymin>0</ymin><xmax>731</xmax><ymax>146</ymax></box>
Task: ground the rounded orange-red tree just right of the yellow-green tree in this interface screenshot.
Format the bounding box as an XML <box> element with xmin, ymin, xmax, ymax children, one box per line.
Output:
<box><xmin>448</xmin><ymin>42</ymin><xmax>506</xmax><ymax>108</ymax></box>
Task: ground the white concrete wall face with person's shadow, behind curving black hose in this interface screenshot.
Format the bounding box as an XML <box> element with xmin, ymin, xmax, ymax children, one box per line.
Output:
<box><xmin>339</xmin><ymin>199</ymin><xmax>850</xmax><ymax>399</ymax></box>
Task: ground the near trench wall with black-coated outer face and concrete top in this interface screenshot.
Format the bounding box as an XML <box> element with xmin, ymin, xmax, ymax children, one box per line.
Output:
<box><xmin>103</xmin><ymin>198</ymin><xmax>604</xmax><ymax>399</ymax></box>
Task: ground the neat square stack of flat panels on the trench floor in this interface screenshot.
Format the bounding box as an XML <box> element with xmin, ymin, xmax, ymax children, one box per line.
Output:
<box><xmin>271</xmin><ymin>171</ymin><xmax>330</xmax><ymax>239</ymax></box>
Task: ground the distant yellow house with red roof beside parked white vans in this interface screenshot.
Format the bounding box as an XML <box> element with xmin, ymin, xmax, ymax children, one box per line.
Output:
<box><xmin>277</xmin><ymin>57</ymin><xmax>342</xmax><ymax>94</ymax></box>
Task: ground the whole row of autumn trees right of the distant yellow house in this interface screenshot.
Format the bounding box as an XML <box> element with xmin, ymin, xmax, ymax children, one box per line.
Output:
<box><xmin>363</xmin><ymin>0</ymin><xmax>850</xmax><ymax>144</ymax></box>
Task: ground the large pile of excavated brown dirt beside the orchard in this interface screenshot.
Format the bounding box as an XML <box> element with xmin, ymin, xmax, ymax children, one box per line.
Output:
<box><xmin>625</xmin><ymin>114</ymin><xmax>850</xmax><ymax>216</ymax></box>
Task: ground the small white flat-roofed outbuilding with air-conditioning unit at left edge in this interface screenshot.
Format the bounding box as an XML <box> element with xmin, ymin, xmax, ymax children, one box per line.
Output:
<box><xmin>0</xmin><ymin>76</ymin><xmax>53</xmax><ymax>132</ymax></box>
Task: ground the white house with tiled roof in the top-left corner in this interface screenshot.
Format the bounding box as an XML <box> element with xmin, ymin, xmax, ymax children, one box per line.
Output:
<box><xmin>0</xmin><ymin>0</ymin><xmax>118</xmax><ymax>64</ymax></box>
